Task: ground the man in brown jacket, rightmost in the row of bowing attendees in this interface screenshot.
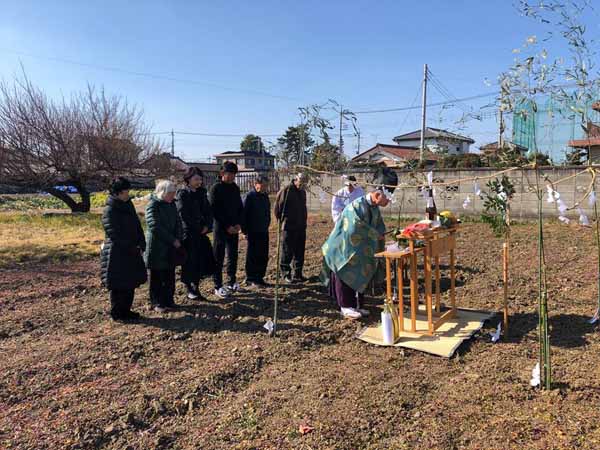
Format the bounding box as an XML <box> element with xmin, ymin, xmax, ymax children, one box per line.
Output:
<box><xmin>274</xmin><ymin>173</ymin><xmax>307</xmax><ymax>283</ymax></box>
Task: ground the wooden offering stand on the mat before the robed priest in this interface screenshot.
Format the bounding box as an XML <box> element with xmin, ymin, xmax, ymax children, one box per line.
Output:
<box><xmin>375</xmin><ymin>226</ymin><xmax>458</xmax><ymax>336</ymax></box>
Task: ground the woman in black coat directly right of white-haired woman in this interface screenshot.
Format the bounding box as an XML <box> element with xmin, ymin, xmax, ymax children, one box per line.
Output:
<box><xmin>175</xmin><ymin>167</ymin><xmax>215</xmax><ymax>300</ymax></box>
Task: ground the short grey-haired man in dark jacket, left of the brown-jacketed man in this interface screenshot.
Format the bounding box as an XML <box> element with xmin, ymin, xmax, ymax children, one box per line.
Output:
<box><xmin>242</xmin><ymin>175</ymin><xmax>271</xmax><ymax>287</ymax></box>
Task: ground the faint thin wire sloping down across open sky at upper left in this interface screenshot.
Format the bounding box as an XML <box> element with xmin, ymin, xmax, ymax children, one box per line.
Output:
<box><xmin>0</xmin><ymin>48</ymin><xmax>302</xmax><ymax>101</ymax></box>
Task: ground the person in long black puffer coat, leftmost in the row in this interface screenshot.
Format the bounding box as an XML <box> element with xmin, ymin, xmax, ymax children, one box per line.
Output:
<box><xmin>100</xmin><ymin>177</ymin><xmax>147</xmax><ymax>321</ymax></box>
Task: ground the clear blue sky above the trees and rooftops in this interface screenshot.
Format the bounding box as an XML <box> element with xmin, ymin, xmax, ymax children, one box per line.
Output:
<box><xmin>0</xmin><ymin>0</ymin><xmax>600</xmax><ymax>160</ymax></box>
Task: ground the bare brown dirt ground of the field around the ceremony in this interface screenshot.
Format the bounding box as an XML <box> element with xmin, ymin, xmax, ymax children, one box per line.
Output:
<box><xmin>0</xmin><ymin>218</ymin><xmax>600</xmax><ymax>450</ymax></box>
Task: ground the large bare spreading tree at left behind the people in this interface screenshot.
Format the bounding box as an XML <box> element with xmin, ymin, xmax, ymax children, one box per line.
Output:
<box><xmin>0</xmin><ymin>75</ymin><xmax>161</xmax><ymax>212</ymax></box>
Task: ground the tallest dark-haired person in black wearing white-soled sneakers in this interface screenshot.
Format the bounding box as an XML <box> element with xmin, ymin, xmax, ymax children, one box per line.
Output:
<box><xmin>209</xmin><ymin>161</ymin><xmax>244</xmax><ymax>298</ymax></box>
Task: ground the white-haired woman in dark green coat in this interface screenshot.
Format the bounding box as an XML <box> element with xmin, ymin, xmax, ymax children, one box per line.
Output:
<box><xmin>144</xmin><ymin>180</ymin><xmax>183</xmax><ymax>313</ymax></box>
